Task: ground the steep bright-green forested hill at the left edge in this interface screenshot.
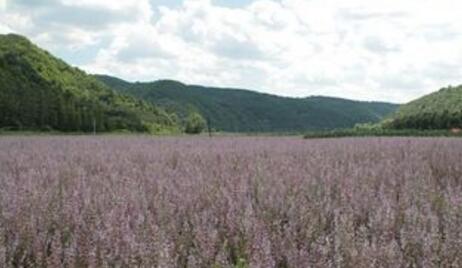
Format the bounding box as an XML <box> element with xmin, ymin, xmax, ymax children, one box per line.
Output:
<box><xmin>0</xmin><ymin>34</ymin><xmax>176</xmax><ymax>132</ymax></box>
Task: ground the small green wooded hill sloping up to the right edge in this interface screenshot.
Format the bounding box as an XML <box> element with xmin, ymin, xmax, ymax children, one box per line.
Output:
<box><xmin>383</xmin><ymin>86</ymin><xmax>462</xmax><ymax>129</ymax></box>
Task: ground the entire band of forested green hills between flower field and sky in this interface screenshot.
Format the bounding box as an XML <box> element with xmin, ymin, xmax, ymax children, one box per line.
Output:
<box><xmin>11</xmin><ymin>34</ymin><xmax>462</xmax><ymax>133</ymax></box>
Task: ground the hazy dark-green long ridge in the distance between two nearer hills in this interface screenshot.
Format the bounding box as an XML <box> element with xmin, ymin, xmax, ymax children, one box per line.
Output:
<box><xmin>97</xmin><ymin>76</ymin><xmax>397</xmax><ymax>132</ymax></box>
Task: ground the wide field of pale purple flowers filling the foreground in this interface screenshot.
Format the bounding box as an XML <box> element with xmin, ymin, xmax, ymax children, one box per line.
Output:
<box><xmin>0</xmin><ymin>137</ymin><xmax>462</xmax><ymax>268</ymax></box>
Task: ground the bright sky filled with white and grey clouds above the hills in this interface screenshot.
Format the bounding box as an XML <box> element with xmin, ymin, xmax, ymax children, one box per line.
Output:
<box><xmin>0</xmin><ymin>0</ymin><xmax>462</xmax><ymax>103</ymax></box>
